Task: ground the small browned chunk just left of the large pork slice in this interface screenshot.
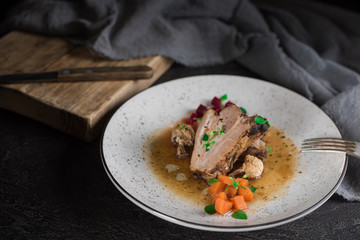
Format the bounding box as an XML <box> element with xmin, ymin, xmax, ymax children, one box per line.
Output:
<box><xmin>171</xmin><ymin>124</ymin><xmax>195</xmax><ymax>158</ymax></box>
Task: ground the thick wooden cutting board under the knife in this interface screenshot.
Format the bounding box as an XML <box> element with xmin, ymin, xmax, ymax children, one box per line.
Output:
<box><xmin>0</xmin><ymin>32</ymin><xmax>173</xmax><ymax>141</ymax></box>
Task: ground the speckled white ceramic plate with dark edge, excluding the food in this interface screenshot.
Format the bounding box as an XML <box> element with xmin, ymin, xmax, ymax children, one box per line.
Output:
<box><xmin>102</xmin><ymin>75</ymin><xmax>347</xmax><ymax>232</ymax></box>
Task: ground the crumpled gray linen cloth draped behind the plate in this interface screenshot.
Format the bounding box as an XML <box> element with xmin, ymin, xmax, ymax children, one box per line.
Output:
<box><xmin>5</xmin><ymin>0</ymin><xmax>360</xmax><ymax>201</ymax></box>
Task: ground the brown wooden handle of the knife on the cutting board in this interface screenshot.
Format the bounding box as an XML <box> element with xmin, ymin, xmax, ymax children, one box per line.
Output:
<box><xmin>58</xmin><ymin>65</ymin><xmax>154</xmax><ymax>82</ymax></box>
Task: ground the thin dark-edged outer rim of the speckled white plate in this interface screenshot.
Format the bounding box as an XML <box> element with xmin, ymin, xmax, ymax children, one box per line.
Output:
<box><xmin>100</xmin><ymin>75</ymin><xmax>348</xmax><ymax>232</ymax></box>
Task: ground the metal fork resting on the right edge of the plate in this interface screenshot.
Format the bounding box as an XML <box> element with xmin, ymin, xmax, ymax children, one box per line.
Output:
<box><xmin>300</xmin><ymin>138</ymin><xmax>360</xmax><ymax>158</ymax></box>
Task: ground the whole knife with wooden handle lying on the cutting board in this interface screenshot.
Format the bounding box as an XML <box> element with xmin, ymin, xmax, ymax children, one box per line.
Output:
<box><xmin>0</xmin><ymin>65</ymin><xmax>154</xmax><ymax>84</ymax></box>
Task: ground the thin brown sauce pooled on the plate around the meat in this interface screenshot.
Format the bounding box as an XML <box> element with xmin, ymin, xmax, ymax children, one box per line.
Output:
<box><xmin>143</xmin><ymin>126</ymin><xmax>298</xmax><ymax>205</ymax></box>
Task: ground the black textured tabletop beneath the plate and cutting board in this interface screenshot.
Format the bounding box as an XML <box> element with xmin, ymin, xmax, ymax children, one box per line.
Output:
<box><xmin>0</xmin><ymin>63</ymin><xmax>360</xmax><ymax>240</ymax></box>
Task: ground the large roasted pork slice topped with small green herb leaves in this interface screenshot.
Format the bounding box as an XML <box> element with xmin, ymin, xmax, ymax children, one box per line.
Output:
<box><xmin>190</xmin><ymin>104</ymin><xmax>261</xmax><ymax>180</ymax></box>
